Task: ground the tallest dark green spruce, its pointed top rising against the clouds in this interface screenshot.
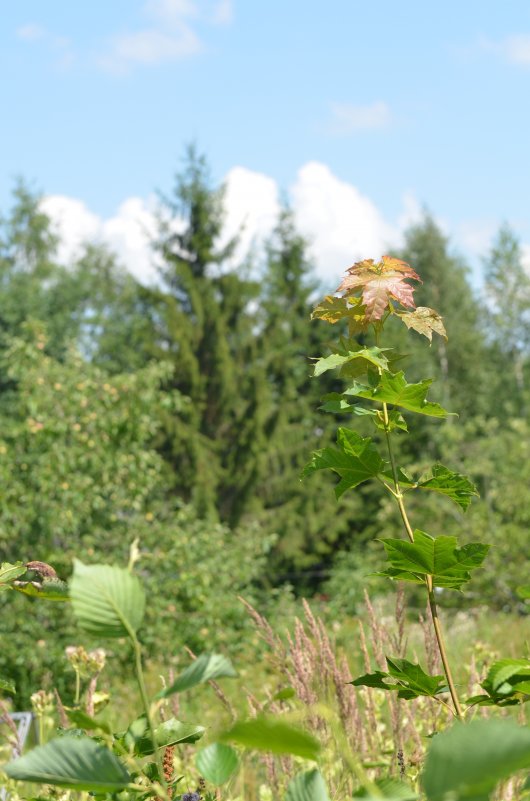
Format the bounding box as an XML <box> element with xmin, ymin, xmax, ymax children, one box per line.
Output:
<box><xmin>152</xmin><ymin>147</ymin><xmax>265</xmax><ymax>524</ymax></box>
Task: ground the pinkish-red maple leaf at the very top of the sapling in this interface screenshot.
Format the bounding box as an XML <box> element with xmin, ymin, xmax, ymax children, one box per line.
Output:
<box><xmin>337</xmin><ymin>256</ymin><xmax>421</xmax><ymax>322</ymax></box>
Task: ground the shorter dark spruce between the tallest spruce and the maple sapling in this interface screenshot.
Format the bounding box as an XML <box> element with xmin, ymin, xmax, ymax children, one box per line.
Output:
<box><xmin>258</xmin><ymin>209</ymin><xmax>376</xmax><ymax>590</ymax></box>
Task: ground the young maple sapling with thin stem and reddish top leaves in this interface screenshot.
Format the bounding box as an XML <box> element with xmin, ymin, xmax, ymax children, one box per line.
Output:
<box><xmin>302</xmin><ymin>256</ymin><xmax>484</xmax><ymax>718</ymax></box>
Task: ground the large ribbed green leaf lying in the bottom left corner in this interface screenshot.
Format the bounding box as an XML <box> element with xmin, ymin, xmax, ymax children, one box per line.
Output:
<box><xmin>4</xmin><ymin>735</ymin><xmax>131</xmax><ymax>794</ymax></box>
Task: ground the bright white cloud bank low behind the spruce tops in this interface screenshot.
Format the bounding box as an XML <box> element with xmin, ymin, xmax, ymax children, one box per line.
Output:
<box><xmin>38</xmin><ymin>162</ymin><xmax>421</xmax><ymax>291</ymax></box>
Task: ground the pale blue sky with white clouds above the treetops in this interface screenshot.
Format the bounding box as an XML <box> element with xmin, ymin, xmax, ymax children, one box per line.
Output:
<box><xmin>0</xmin><ymin>0</ymin><xmax>530</xmax><ymax>286</ymax></box>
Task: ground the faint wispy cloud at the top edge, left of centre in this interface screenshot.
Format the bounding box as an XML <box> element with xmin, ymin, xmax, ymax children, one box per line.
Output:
<box><xmin>97</xmin><ymin>0</ymin><xmax>232</xmax><ymax>73</ymax></box>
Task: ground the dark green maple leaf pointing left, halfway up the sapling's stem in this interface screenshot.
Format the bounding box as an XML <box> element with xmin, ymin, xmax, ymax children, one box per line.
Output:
<box><xmin>301</xmin><ymin>428</ymin><xmax>385</xmax><ymax>498</ymax></box>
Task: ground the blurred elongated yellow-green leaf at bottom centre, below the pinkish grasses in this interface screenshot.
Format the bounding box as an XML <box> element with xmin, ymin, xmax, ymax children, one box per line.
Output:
<box><xmin>222</xmin><ymin>717</ymin><xmax>320</xmax><ymax>759</ymax></box>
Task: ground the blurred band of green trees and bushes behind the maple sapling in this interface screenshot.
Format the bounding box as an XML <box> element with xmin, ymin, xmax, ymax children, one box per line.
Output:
<box><xmin>0</xmin><ymin>147</ymin><xmax>530</xmax><ymax>705</ymax></box>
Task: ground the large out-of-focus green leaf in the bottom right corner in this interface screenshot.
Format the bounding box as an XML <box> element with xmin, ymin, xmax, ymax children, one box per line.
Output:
<box><xmin>422</xmin><ymin>718</ymin><xmax>530</xmax><ymax>801</ymax></box>
